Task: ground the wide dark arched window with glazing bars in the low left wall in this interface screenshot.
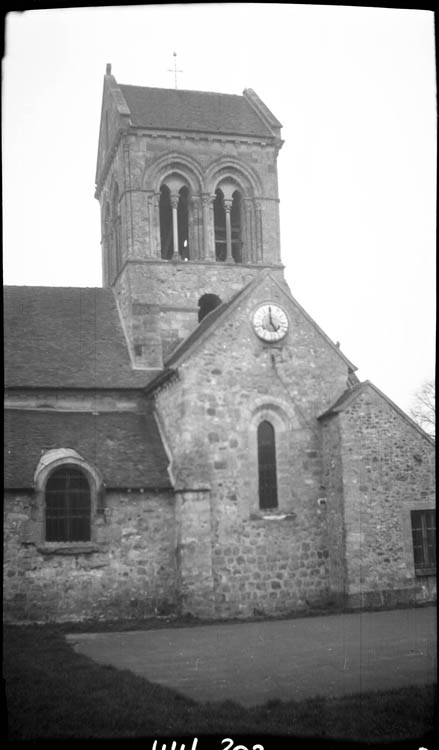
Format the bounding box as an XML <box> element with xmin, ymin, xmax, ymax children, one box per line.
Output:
<box><xmin>45</xmin><ymin>465</ymin><xmax>91</xmax><ymax>542</ymax></box>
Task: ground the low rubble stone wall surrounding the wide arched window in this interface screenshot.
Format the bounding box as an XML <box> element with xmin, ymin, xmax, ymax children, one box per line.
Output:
<box><xmin>3</xmin><ymin>491</ymin><xmax>177</xmax><ymax>622</ymax></box>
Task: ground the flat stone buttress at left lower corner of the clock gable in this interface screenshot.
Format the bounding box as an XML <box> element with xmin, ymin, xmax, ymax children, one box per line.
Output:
<box><xmin>175</xmin><ymin>487</ymin><xmax>215</xmax><ymax>617</ymax></box>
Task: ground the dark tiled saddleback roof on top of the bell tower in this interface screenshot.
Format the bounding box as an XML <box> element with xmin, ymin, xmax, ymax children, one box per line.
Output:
<box><xmin>119</xmin><ymin>84</ymin><xmax>280</xmax><ymax>137</ymax></box>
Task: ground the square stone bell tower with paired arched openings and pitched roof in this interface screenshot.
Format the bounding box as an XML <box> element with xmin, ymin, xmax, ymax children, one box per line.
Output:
<box><xmin>95</xmin><ymin>65</ymin><xmax>283</xmax><ymax>369</ymax></box>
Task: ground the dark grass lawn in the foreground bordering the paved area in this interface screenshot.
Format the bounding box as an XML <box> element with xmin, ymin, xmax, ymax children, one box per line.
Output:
<box><xmin>3</xmin><ymin>626</ymin><xmax>437</xmax><ymax>750</ymax></box>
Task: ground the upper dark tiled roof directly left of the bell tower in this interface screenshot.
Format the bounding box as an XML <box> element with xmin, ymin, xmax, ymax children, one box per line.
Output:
<box><xmin>4</xmin><ymin>286</ymin><xmax>155</xmax><ymax>388</ymax></box>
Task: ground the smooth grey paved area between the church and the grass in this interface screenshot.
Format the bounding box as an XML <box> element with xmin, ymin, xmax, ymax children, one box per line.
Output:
<box><xmin>66</xmin><ymin>607</ymin><xmax>436</xmax><ymax>706</ymax></box>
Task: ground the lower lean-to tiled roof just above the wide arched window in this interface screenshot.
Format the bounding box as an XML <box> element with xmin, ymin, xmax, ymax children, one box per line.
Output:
<box><xmin>4</xmin><ymin>404</ymin><xmax>170</xmax><ymax>488</ymax></box>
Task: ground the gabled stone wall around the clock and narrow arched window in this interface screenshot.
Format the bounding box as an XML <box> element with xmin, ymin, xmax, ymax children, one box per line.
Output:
<box><xmin>156</xmin><ymin>278</ymin><xmax>354</xmax><ymax>617</ymax></box>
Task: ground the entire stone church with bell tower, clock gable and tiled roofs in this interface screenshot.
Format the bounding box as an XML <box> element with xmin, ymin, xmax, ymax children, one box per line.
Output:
<box><xmin>4</xmin><ymin>66</ymin><xmax>436</xmax><ymax>622</ymax></box>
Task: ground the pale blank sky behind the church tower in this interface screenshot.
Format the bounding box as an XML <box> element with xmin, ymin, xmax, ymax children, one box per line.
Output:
<box><xmin>2</xmin><ymin>3</ymin><xmax>436</xmax><ymax>410</ymax></box>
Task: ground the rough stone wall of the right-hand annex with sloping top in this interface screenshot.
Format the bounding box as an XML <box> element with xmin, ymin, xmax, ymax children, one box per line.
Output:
<box><xmin>340</xmin><ymin>388</ymin><xmax>436</xmax><ymax>606</ymax></box>
